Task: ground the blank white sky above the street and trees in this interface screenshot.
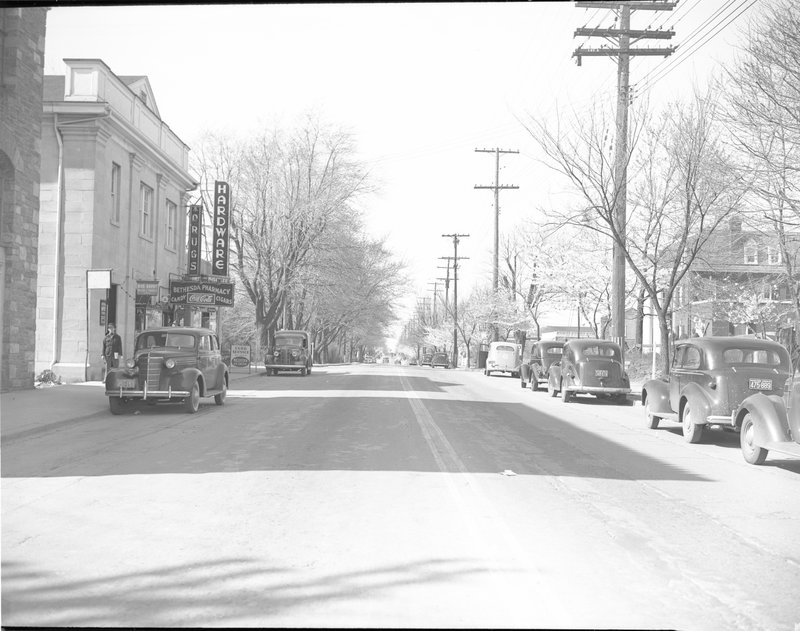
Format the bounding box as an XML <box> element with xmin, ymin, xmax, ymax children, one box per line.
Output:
<box><xmin>45</xmin><ymin>0</ymin><xmax>769</xmax><ymax>330</ymax></box>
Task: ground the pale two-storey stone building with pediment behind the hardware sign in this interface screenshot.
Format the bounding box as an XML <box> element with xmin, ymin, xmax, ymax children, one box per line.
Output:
<box><xmin>35</xmin><ymin>59</ymin><xmax>197</xmax><ymax>381</ymax></box>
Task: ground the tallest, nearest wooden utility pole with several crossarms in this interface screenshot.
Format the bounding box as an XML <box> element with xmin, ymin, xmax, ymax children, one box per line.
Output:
<box><xmin>572</xmin><ymin>0</ymin><xmax>677</xmax><ymax>355</ymax></box>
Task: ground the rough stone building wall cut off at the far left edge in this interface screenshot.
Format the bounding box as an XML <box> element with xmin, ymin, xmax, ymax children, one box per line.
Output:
<box><xmin>0</xmin><ymin>7</ymin><xmax>47</xmax><ymax>391</ymax></box>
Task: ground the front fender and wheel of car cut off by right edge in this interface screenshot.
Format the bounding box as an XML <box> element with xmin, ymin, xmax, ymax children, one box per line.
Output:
<box><xmin>734</xmin><ymin>382</ymin><xmax>800</xmax><ymax>464</ymax></box>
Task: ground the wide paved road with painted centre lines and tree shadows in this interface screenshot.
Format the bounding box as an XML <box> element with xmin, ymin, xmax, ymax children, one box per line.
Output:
<box><xmin>2</xmin><ymin>365</ymin><xmax>800</xmax><ymax>630</ymax></box>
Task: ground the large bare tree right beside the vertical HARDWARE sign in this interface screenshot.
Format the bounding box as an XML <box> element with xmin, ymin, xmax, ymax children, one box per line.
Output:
<box><xmin>197</xmin><ymin>118</ymin><xmax>367</xmax><ymax>346</ymax></box>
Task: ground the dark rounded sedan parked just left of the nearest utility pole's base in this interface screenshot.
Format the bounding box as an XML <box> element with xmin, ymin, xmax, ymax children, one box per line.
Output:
<box><xmin>547</xmin><ymin>339</ymin><xmax>631</xmax><ymax>403</ymax></box>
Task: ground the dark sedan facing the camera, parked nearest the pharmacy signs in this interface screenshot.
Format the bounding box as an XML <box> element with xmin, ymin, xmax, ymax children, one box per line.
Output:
<box><xmin>105</xmin><ymin>327</ymin><xmax>228</xmax><ymax>414</ymax></box>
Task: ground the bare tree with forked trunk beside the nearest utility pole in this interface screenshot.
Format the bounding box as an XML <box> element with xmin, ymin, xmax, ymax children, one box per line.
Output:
<box><xmin>526</xmin><ymin>95</ymin><xmax>746</xmax><ymax>374</ymax></box>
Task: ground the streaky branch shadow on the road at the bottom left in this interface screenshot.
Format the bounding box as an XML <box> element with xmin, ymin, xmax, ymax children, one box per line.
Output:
<box><xmin>2</xmin><ymin>558</ymin><xmax>488</xmax><ymax>628</ymax></box>
